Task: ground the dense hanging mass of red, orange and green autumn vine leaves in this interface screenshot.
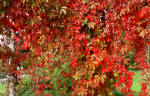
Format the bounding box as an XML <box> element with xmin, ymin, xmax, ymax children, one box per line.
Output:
<box><xmin>0</xmin><ymin>0</ymin><xmax>150</xmax><ymax>96</ymax></box>
